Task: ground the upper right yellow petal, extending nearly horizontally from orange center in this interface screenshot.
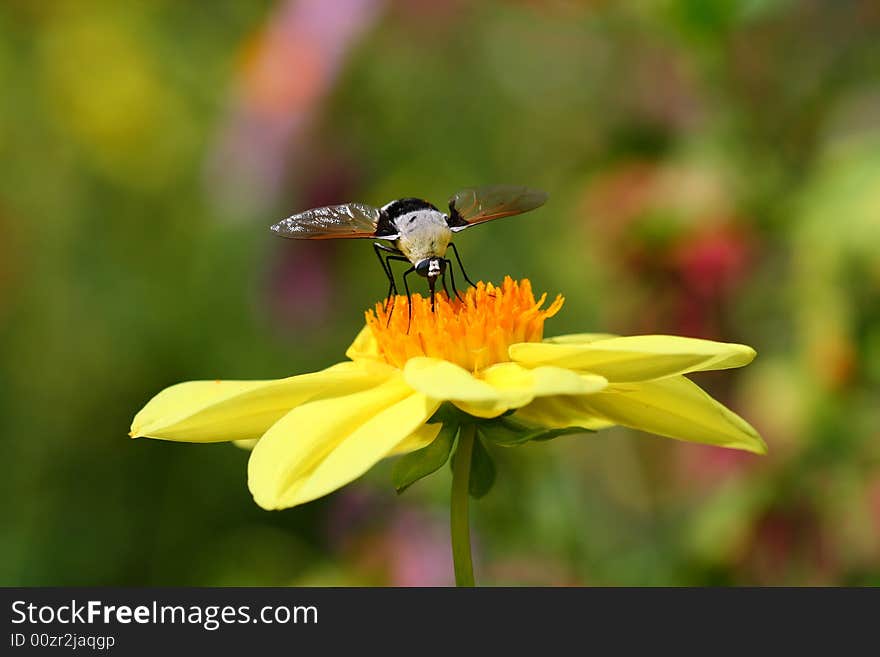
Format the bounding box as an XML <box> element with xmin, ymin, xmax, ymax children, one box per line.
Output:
<box><xmin>510</xmin><ymin>335</ymin><xmax>755</xmax><ymax>383</ymax></box>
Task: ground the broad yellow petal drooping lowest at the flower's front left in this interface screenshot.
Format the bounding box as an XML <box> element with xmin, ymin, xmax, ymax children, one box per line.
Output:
<box><xmin>248</xmin><ymin>376</ymin><xmax>439</xmax><ymax>509</ymax></box>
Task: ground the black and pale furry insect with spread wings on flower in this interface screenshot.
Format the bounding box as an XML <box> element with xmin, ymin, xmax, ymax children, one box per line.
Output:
<box><xmin>271</xmin><ymin>185</ymin><xmax>547</xmax><ymax>320</ymax></box>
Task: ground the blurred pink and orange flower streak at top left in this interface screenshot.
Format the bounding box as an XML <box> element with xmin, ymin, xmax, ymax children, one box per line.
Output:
<box><xmin>209</xmin><ymin>0</ymin><xmax>384</xmax><ymax>214</ymax></box>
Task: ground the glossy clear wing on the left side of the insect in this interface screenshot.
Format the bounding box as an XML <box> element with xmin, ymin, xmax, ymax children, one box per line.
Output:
<box><xmin>272</xmin><ymin>203</ymin><xmax>380</xmax><ymax>240</ymax></box>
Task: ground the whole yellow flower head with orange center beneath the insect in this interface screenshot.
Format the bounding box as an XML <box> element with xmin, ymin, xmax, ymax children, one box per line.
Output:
<box><xmin>131</xmin><ymin>277</ymin><xmax>766</xmax><ymax>509</ymax></box>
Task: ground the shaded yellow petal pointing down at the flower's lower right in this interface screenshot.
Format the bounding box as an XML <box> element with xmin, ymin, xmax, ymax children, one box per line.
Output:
<box><xmin>581</xmin><ymin>377</ymin><xmax>767</xmax><ymax>454</ymax></box>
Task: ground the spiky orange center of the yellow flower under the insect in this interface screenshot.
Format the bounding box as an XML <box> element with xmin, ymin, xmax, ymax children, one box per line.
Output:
<box><xmin>366</xmin><ymin>276</ymin><xmax>564</xmax><ymax>372</ymax></box>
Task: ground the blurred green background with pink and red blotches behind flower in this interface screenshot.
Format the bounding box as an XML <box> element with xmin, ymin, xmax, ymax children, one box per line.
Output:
<box><xmin>0</xmin><ymin>0</ymin><xmax>880</xmax><ymax>585</ymax></box>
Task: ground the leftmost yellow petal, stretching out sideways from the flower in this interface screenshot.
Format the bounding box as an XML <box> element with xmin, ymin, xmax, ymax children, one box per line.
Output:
<box><xmin>131</xmin><ymin>363</ymin><xmax>393</xmax><ymax>442</ymax></box>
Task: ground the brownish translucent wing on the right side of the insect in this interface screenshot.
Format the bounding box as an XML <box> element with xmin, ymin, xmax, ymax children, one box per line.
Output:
<box><xmin>449</xmin><ymin>185</ymin><xmax>547</xmax><ymax>231</ymax></box>
